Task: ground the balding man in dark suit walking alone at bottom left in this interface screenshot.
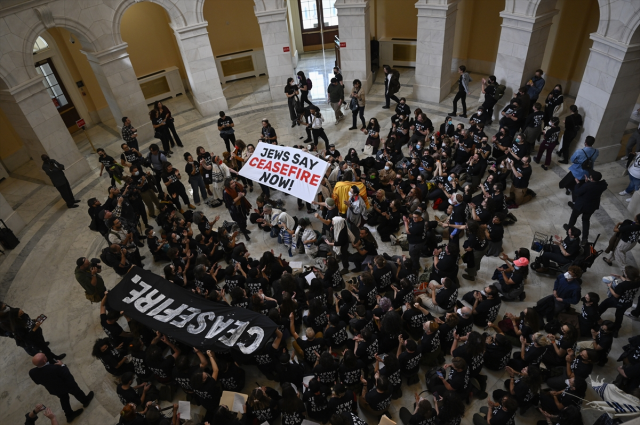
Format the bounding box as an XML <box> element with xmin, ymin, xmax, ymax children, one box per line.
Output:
<box><xmin>29</xmin><ymin>353</ymin><xmax>93</xmax><ymax>422</ymax></box>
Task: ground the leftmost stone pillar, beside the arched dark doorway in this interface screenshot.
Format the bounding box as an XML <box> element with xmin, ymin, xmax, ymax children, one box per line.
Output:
<box><xmin>0</xmin><ymin>76</ymin><xmax>90</xmax><ymax>186</ymax></box>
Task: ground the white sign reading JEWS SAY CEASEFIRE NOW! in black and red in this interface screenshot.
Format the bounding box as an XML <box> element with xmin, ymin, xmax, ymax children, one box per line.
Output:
<box><xmin>239</xmin><ymin>142</ymin><xmax>329</xmax><ymax>202</ymax></box>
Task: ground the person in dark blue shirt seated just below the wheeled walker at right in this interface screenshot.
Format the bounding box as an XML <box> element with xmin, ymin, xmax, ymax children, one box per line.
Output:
<box><xmin>534</xmin><ymin>266</ymin><xmax>582</xmax><ymax>322</ymax></box>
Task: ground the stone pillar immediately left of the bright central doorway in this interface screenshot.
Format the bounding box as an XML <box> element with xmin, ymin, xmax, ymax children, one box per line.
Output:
<box><xmin>253</xmin><ymin>0</ymin><xmax>294</xmax><ymax>101</ymax></box>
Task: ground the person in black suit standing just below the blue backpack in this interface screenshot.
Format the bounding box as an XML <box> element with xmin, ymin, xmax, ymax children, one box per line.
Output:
<box><xmin>563</xmin><ymin>171</ymin><xmax>609</xmax><ymax>245</ymax></box>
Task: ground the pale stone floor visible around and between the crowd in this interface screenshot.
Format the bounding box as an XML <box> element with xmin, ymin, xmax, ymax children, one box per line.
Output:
<box><xmin>0</xmin><ymin>54</ymin><xmax>640</xmax><ymax>425</ymax></box>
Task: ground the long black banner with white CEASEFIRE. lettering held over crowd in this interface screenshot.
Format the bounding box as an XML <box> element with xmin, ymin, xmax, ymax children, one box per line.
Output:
<box><xmin>107</xmin><ymin>267</ymin><xmax>277</xmax><ymax>354</ymax></box>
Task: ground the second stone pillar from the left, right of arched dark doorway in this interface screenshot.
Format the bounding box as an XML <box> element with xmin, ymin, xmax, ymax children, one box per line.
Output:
<box><xmin>83</xmin><ymin>43</ymin><xmax>154</xmax><ymax>142</ymax></box>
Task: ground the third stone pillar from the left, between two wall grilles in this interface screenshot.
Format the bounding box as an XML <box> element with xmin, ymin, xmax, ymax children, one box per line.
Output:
<box><xmin>174</xmin><ymin>22</ymin><xmax>228</xmax><ymax>117</ymax></box>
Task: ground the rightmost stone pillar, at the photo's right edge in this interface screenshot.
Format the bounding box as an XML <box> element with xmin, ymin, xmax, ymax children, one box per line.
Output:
<box><xmin>574</xmin><ymin>33</ymin><xmax>640</xmax><ymax>163</ymax></box>
